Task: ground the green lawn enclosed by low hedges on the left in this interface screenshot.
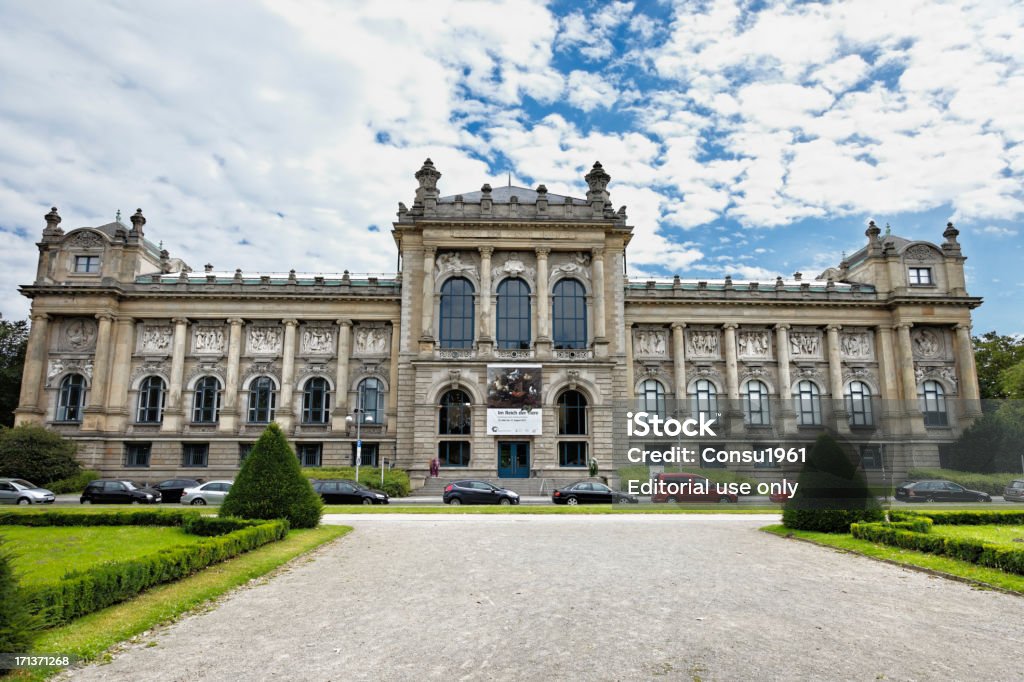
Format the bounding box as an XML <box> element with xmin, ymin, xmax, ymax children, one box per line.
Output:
<box><xmin>0</xmin><ymin>525</ymin><xmax>205</xmax><ymax>585</ymax></box>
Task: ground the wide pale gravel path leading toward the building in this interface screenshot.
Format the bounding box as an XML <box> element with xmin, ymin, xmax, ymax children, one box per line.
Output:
<box><xmin>66</xmin><ymin>515</ymin><xmax>1024</xmax><ymax>682</ymax></box>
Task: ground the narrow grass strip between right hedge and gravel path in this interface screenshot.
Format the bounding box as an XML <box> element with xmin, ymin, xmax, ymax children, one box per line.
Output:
<box><xmin>762</xmin><ymin>524</ymin><xmax>1024</xmax><ymax>595</ymax></box>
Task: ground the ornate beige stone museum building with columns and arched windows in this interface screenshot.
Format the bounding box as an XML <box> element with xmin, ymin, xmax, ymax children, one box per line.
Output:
<box><xmin>16</xmin><ymin>160</ymin><xmax>981</xmax><ymax>492</ymax></box>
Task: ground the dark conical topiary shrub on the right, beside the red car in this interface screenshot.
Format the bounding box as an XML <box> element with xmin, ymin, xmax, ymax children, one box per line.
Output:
<box><xmin>782</xmin><ymin>433</ymin><xmax>883</xmax><ymax>532</ymax></box>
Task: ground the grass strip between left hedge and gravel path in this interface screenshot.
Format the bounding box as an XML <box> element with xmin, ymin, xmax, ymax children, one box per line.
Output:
<box><xmin>13</xmin><ymin>525</ymin><xmax>351</xmax><ymax>680</ymax></box>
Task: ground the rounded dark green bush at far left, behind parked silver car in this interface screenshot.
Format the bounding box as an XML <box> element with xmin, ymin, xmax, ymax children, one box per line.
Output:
<box><xmin>0</xmin><ymin>424</ymin><xmax>82</xmax><ymax>486</ymax></box>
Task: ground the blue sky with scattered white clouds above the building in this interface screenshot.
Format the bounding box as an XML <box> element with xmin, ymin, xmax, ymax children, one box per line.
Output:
<box><xmin>0</xmin><ymin>0</ymin><xmax>1024</xmax><ymax>334</ymax></box>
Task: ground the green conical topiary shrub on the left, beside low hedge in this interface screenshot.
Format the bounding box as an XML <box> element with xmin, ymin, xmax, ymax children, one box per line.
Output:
<box><xmin>220</xmin><ymin>424</ymin><xmax>324</xmax><ymax>528</ymax></box>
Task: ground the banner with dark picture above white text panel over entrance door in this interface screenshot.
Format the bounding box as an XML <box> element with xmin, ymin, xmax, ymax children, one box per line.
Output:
<box><xmin>487</xmin><ymin>364</ymin><xmax>543</xmax><ymax>435</ymax></box>
